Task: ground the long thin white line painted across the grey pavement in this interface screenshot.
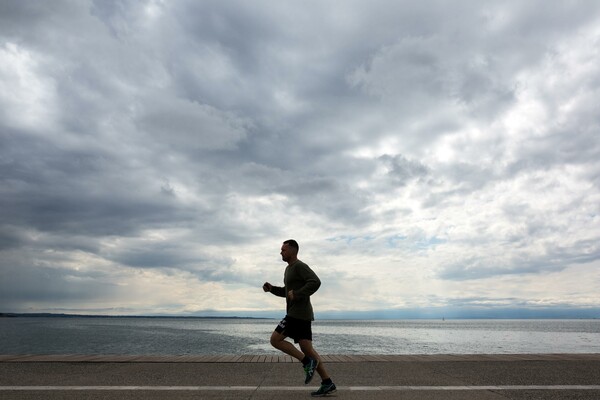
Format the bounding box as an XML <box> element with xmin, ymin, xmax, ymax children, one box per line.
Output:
<box><xmin>0</xmin><ymin>385</ymin><xmax>600</xmax><ymax>392</ymax></box>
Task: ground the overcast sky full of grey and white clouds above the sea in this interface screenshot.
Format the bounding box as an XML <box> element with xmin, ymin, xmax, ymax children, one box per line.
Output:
<box><xmin>0</xmin><ymin>0</ymin><xmax>600</xmax><ymax>317</ymax></box>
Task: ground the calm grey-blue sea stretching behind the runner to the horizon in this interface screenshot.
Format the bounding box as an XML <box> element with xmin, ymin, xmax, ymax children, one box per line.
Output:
<box><xmin>0</xmin><ymin>317</ymin><xmax>600</xmax><ymax>355</ymax></box>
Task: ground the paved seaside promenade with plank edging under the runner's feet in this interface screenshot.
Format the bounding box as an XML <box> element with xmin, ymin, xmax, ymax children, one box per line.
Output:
<box><xmin>0</xmin><ymin>354</ymin><xmax>600</xmax><ymax>400</ymax></box>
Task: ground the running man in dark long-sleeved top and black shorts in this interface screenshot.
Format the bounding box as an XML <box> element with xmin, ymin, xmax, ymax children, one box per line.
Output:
<box><xmin>263</xmin><ymin>239</ymin><xmax>336</xmax><ymax>397</ymax></box>
